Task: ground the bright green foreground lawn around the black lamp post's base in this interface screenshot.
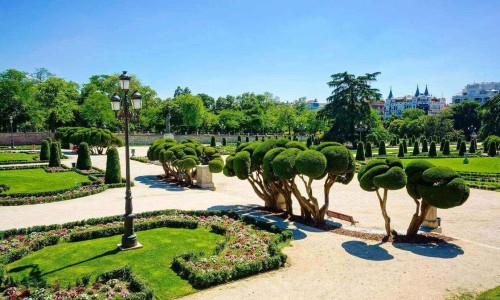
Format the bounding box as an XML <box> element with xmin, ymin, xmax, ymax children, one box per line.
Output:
<box><xmin>7</xmin><ymin>228</ymin><xmax>223</xmax><ymax>299</ymax></box>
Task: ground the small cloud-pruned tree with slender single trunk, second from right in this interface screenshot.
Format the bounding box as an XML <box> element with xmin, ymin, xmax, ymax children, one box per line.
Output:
<box><xmin>358</xmin><ymin>158</ymin><xmax>407</xmax><ymax>236</ymax></box>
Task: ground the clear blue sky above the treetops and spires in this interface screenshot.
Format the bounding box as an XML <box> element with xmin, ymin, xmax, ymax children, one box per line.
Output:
<box><xmin>0</xmin><ymin>0</ymin><xmax>500</xmax><ymax>101</ymax></box>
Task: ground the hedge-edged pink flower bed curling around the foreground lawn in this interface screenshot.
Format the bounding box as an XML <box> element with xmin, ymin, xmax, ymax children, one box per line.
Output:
<box><xmin>0</xmin><ymin>210</ymin><xmax>292</xmax><ymax>299</ymax></box>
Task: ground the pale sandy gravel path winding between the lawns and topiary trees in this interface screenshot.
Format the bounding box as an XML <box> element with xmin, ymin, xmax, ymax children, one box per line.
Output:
<box><xmin>0</xmin><ymin>147</ymin><xmax>500</xmax><ymax>300</ymax></box>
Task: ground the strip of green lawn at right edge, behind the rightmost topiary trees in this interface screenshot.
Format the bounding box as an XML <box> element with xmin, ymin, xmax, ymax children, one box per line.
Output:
<box><xmin>401</xmin><ymin>157</ymin><xmax>500</xmax><ymax>173</ymax></box>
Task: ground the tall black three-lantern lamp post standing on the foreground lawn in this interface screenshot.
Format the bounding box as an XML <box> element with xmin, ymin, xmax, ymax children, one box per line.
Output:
<box><xmin>111</xmin><ymin>71</ymin><xmax>142</xmax><ymax>250</ymax></box>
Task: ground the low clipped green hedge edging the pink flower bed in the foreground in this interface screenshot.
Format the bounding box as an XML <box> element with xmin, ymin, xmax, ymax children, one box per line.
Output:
<box><xmin>0</xmin><ymin>209</ymin><xmax>292</xmax><ymax>293</ymax></box>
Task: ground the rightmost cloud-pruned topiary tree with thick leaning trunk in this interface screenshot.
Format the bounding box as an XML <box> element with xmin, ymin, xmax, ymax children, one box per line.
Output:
<box><xmin>405</xmin><ymin>160</ymin><xmax>470</xmax><ymax>235</ymax></box>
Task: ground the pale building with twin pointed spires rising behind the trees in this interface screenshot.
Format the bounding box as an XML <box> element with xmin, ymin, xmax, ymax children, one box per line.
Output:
<box><xmin>384</xmin><ymin>85</ymin><xmax>446</xmax><ymax>119</ymax></box>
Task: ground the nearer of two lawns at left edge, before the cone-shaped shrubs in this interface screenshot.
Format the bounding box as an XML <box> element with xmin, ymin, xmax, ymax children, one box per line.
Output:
<box><xmin>0</xmin><ymin>168</ymin><xmax>90</xmax><ymax>195</ymax></box>
